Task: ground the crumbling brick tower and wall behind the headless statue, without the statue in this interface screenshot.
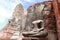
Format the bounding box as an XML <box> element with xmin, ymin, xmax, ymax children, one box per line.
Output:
<box><xmin>0</xmin><ymin>1</ymin><xmax>60</xmax><ymax>40</ymax></box>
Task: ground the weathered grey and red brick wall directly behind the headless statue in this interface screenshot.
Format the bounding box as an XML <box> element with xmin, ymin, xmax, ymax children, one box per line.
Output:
<box><xmin>25</xmin><ymin>2</ymin><xmax>56</xmax><ymax>40</ymax></box>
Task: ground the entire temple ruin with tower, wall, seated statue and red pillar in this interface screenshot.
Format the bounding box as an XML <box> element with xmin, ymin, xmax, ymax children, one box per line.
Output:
<box><xmin>0</xmin><ymin>0</ymin><xmax>60</xmax><ymax>40</ymax></box>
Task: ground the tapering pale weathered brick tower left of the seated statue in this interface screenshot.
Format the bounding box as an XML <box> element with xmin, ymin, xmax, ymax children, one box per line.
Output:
<box><xmin>0</xmin><ymin>4</ymin><xmax>24</xmax><ymax>40</ymax></box>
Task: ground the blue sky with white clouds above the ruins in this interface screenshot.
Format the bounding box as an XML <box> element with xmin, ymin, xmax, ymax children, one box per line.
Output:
<box><xmin>0</xmin><ymin>0</ymin><xmax>47</xmax><ymax>30</ymax></box>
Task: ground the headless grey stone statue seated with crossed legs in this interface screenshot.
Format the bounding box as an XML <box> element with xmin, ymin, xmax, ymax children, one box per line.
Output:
<box><xmin>22</xmin><ymin>20</ymin><xmax>48</xmax><ymax>37</ymax></box>
